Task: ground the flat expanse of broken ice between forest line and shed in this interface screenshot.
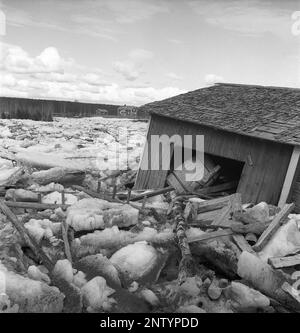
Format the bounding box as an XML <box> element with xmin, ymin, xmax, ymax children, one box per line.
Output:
<box><xmin>0</xmin><ymin>117</ymin><xmax>147</xmax><ymax>174</ymax></box>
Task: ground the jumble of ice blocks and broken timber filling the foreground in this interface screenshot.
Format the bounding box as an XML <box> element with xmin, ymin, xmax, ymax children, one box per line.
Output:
<box><xmin>0</xmin><ymin>118</ymin><xmax>300</xmax><ymax>313</ymax></box>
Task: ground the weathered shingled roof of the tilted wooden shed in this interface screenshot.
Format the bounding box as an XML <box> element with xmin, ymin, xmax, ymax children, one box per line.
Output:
<box><xmin>140</xmin><ymin>83</ymin><xmax>300</xmax><ymax>145</ymax></box>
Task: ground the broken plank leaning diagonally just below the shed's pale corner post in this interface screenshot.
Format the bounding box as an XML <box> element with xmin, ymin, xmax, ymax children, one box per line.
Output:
<box><xmin>253</xmin><ymin>203</ymin><xmax>295</xmax><ymax>252</ymax></box>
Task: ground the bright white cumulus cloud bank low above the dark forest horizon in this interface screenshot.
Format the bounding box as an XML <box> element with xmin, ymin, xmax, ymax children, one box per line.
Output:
<box><xmin>0</xmin><ymin>44</ymin><xmax>183</xmax><ymax>105</ymax></box>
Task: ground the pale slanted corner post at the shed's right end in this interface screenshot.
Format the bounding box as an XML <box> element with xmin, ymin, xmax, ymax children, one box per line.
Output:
<box><xmin>278</xmin><ymin>146</ymin><xmax>300</xmax><ymax>208</ymax></box>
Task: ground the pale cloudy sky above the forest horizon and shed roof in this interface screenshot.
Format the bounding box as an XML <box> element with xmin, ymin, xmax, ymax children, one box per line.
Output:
<box><xmin>0</xmin><ymin>0</ymin><xmax>300</xmax><ymax>105</ymax></box>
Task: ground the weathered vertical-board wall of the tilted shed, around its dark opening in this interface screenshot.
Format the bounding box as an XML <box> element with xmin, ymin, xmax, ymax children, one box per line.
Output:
<box><xmin>135</xmin><ymin>115</ymin><xmax>293</xmax><ymax>204</ymax></box>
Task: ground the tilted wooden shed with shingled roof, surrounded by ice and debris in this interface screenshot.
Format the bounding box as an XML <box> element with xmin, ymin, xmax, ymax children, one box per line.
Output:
<box><xmin>135</xmin><ymin>83</ymin><xmax>300</xmax><ymax>210</ymax></box>
